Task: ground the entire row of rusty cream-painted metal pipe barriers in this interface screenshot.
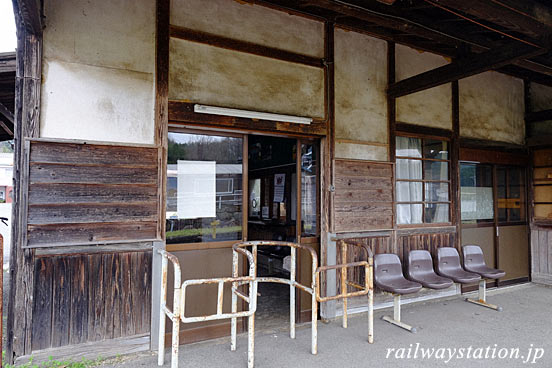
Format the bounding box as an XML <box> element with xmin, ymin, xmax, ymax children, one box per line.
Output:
<box><xmin>158</xmin><ymin>240</ymin><xmax>374</xmax><ymax>368</ymax></box>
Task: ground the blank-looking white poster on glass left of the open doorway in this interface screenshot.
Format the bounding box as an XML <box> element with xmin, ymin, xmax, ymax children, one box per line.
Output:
<box><xmin>176</xmin><ymin>160</ymin><xmax>217</xmax><ymax>219</ymax></box>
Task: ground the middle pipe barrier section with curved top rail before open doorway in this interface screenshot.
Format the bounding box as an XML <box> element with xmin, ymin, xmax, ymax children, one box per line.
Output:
<box><xmin>231</xmin><ymin>241</ymin><xmax>318</xmax><ymax>354</ymax></box>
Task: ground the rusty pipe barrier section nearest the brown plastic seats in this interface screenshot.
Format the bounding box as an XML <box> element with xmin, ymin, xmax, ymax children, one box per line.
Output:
<box><xmin>316</xmin><ymin>239</ymin><xmax>374</xmax><ymax>344</ymax></box>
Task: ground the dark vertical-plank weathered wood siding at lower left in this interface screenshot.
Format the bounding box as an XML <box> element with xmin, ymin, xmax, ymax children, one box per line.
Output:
<box><xmin>32</xmin><ymin>251</ymin><xmax>152</xmax><ymax>351</ymax></box>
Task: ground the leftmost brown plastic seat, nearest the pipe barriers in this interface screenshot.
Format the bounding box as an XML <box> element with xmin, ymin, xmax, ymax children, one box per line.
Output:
<box><xmin>374</xmin><ymin>254</ymin><xmax>422</xmax><ymax>295</ymax></box>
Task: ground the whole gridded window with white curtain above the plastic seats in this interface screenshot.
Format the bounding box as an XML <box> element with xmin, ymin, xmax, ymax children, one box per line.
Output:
<box><xmin>395</xmin><ymin>136</ymin><xmax>450</xmax><ymax>225</ymax></box>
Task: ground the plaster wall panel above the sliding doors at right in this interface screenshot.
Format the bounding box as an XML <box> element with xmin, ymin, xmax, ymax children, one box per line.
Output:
<box><xmin>459</xmin><ymin>71</ymin><xmax>525</xmax><ymax>144</ymax></box>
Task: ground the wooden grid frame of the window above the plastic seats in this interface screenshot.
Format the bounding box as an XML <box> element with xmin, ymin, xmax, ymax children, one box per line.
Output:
<box><xmin>393</xmin><ymin>132</ymin><xmax>453</xmax><ymax>228</ymax></box>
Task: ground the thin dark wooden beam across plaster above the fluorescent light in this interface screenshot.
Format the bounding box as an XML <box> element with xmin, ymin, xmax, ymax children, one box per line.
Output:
<box><xmin>170</xmin><ymin>26</ymin><xmax>324</xmax><ymax>68</ymax></box>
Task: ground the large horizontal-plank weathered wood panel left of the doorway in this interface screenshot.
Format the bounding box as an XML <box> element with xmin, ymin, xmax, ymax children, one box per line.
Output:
<box><xmin>26</xmin><ymin>141</ymin><xmax>159</xmax><ymax>247</ymax></box>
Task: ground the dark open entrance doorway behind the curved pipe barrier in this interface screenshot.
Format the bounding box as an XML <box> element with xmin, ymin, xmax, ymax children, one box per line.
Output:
<box><xmin>247</xmin><ymin>135</ymin><xmax>319</xmax><ymax>329</ymax></box>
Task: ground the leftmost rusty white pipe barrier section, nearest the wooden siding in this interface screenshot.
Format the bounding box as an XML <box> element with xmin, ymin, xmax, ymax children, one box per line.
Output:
<box><xmin>157</xmin><ymin>247</ymin><xmax>257</xmax><ymax>368</ymax></box>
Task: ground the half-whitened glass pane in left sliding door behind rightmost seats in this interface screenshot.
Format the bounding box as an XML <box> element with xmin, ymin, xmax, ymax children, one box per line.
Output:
<box><xmin>460</xmin><ymin>164</ymin><xmax>494</xmax><ymax>222</ymax></box>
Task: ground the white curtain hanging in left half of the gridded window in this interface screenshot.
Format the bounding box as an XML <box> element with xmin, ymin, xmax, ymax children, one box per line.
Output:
<box><xmin>396</xmin><ymin>137</ymin><xmax>422</xmax><ymax>224</ymax></box>
